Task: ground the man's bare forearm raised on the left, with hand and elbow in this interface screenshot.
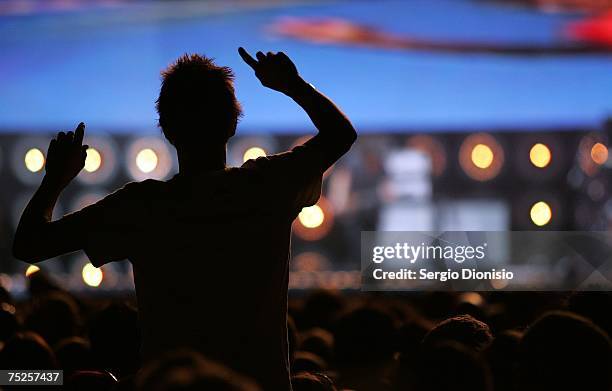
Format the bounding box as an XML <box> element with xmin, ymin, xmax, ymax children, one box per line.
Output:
<box><xmin>13</xmin><ymin>122</ymin><xmax>88</xmax><ymax>263</ymax></box>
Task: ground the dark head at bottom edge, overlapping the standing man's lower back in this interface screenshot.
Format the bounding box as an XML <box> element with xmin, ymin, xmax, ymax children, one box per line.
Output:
<box><xmin>136</xmin><ymin>350</ymin><xmax>260</xmax><ymax>391</ymax></box>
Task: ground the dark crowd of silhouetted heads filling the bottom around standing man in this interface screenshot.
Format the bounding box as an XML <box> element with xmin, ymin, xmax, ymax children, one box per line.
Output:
<box><xmin>0</xmin><ymin>273</ymin><xmax>612</xmax><ymax>391</ymax></box>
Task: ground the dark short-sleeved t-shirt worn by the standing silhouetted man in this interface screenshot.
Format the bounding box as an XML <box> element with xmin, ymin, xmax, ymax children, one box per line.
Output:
<box><xmin>64</xmin><ymin>144</ymin><xmax>322</xmax><ymax>390</ymax></box>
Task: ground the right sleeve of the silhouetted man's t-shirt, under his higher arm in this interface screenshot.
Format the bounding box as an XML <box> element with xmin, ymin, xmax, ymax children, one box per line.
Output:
<box><xmin>243</xmin><ymin>143</ymin><xmax>323</xmax><ymax>211</ymax></box>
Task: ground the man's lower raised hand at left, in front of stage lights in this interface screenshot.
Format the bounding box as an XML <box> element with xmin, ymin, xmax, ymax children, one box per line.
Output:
<box><xmin>45</xmin><ymin>122</ymin><xmax>89</xmax><ymax>188</ymax></box>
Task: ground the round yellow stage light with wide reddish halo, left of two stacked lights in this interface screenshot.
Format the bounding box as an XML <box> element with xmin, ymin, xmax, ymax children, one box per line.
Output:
<box><xmin>459</xmin><ymin>133</ymin><xmax>504</xmax><ymax>181</ymax></box>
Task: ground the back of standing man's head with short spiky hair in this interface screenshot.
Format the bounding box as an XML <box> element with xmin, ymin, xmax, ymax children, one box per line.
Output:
<box><xmin>157</xmin><ymin>54</ymin><xmax>241</xmax><ymax>148</ymax></box>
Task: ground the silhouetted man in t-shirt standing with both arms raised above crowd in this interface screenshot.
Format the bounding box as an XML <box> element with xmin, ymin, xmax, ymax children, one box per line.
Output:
<box><xmin>13</xmin><ymin>48</ymin><xmax>356</xmax><ymax>390</ymax></box>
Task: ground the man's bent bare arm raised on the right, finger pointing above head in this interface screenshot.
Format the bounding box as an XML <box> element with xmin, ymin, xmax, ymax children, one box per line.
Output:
<box><xmin>238</xmin><ymin>48</ymin><xmax>357</xmax><ymax>172</ymax></box>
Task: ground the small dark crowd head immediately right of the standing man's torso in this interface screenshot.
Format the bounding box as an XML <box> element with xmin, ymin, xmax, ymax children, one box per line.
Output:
<box><xmin>298</xmin><ymin>289</ymin><xmax>344</xmax><ymax>330</ymax></box>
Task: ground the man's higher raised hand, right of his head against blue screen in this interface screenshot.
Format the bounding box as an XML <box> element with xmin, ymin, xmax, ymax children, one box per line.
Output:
<box><xmin>238</xmin><ymin>47</ymin><xmax>304</xmax><ymax>96</ymax></box>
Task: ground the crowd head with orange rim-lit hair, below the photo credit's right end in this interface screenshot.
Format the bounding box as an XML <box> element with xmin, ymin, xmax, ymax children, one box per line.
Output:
<box><xmin>423</xmin><ymin>315</ymin><xmax>493</xmax><ymax>352</ymax></box>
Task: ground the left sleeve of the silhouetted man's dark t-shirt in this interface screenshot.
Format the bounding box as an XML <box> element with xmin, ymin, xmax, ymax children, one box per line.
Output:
<box><xmin>61</xmin><ymin>183</ymin><xmax>142</xmax><ymax>267</ymax></box>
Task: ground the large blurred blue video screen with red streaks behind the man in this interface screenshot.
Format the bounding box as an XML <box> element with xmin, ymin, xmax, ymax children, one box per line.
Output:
<box><xmin>0</xmin><ymin>0</ymin><xmax>612</xmax><ymax>134</ymax></box>
